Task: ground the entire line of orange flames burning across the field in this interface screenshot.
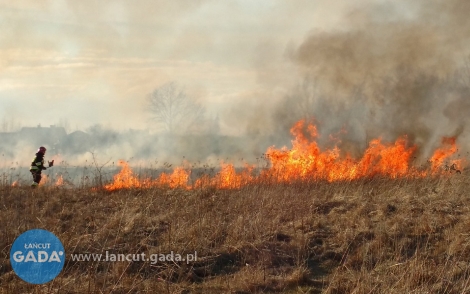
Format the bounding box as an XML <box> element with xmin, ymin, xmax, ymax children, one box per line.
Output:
<box><xmin>105</xmin><ymin>120</ymin><xmax>463</xmax><ymax>191</ymax></box>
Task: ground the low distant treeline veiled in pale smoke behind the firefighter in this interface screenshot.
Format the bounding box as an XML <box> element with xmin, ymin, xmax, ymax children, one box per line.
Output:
<box><xmin>0</xmin><ymin>126</ymin><xmax>290</xmax><ymax>162</ymax></box>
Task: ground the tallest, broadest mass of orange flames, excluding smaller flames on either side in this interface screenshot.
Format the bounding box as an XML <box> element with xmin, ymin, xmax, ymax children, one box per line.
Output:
<box><xmin>265</xmin><ymin>121</ymin><xmax>416</xmax><ymax>182</ymax></box>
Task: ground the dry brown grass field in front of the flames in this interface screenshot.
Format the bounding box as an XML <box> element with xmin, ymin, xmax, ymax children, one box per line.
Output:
<box><xmin>0</xmin><ymin>173</ymin><xmax>470</xmax><ymax>293</ymax></box>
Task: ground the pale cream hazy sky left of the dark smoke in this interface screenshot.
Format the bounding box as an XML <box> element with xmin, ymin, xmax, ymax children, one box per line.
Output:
<box><xmin>0</xmin><ymin>0</ymin><xmax>383</xmax><ymax>132</ymax></box>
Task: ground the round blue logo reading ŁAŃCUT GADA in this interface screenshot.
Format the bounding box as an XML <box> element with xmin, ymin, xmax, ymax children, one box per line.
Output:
<box><xmin>10</xmin><ymin>229</ymin><xmax>65</xmax><ymax>284</ymax></box>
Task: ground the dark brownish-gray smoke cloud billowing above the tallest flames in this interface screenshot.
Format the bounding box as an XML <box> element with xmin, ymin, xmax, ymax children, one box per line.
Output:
<box><xmin>273</xmin><ymin>0</ymin><xmax>470</xmax><ymax>161</ymax></box>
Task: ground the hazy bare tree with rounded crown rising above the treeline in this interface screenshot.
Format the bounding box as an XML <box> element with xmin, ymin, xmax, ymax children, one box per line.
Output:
<box><xmin>148</xmin><ymin>82</ymin><xmax>205</xmax><ymax>134</ymax></box>
